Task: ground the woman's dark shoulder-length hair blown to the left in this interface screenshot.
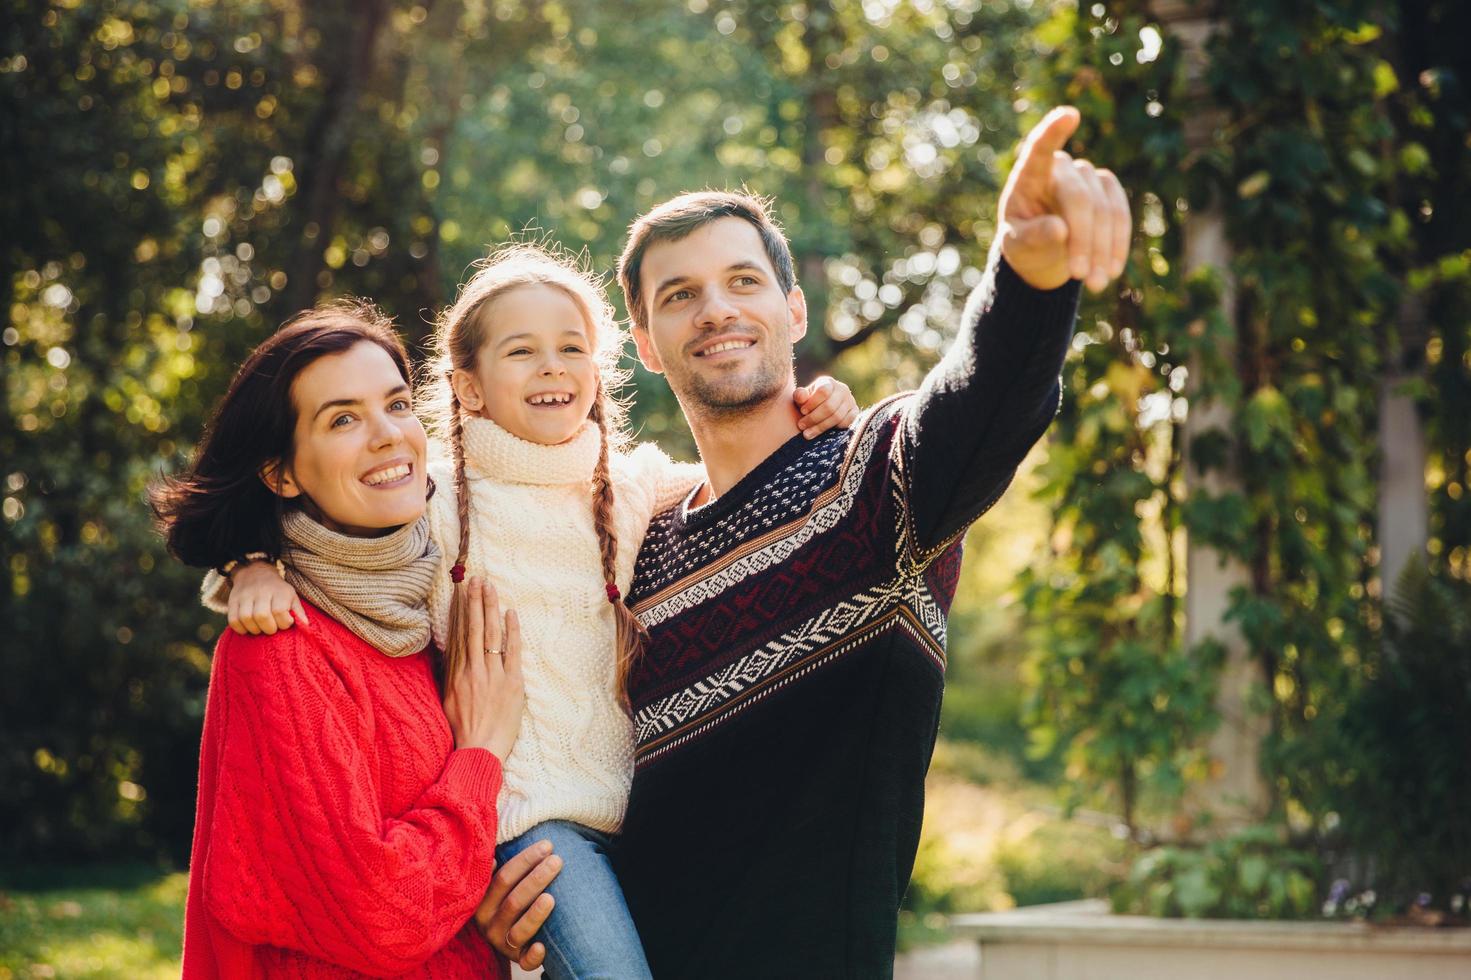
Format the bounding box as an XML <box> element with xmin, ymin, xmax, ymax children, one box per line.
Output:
<box><xmin>149</xmin><ymin>300</ymin><xmax>413</xmax><ymax>568</ymax></box>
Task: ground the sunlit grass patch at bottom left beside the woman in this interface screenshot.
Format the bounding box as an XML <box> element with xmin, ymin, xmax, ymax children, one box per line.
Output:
<box><xmin>0</xmin><ymin>865</ymin><xmax>188</xmax><ymax>980</ymax></box>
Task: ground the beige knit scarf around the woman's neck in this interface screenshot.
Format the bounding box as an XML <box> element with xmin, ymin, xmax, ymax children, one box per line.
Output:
<box><xmin>281</xmin><ymin>511</ymin><xmax>440</xmax><ymax>656</ymax></box>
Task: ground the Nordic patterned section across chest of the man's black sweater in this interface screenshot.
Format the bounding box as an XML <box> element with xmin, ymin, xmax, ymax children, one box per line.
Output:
<box><xmin>634</xmin><ymin>396</ymin><xmax>959</xmax><ymax>767</ymax></box>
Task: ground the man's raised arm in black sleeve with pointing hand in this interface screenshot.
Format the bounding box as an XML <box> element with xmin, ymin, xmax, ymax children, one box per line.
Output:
<box><xmin>900</xmin><ymin>106</ymin><xmax>1133</xmax><ymax>552</ymax></box>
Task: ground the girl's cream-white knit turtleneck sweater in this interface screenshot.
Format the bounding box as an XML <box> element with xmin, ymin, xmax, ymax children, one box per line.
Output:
<box><xmin>430</xmin><ymin>418</ymin><xmax>703</xmax><ymax>843</ymax></box>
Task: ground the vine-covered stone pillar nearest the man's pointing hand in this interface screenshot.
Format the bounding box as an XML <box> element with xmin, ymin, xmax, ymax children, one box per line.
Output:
<box><xmin>1150</xmin><ymin>0</ymin><xmax>1271</xmax><ymax>836</ymax></box>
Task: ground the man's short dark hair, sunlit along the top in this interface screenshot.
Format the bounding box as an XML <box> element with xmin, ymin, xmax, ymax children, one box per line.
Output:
<box><xmin>618</xmin><ymin>191</ymin><xmax>797</xmax><ymax>330</ymax></box>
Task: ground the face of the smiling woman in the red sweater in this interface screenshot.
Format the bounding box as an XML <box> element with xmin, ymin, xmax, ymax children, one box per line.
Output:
<box><xmin>266</xmin><ymin>341</ymin><xmax>427</xmax><ymax>537</ymax></box>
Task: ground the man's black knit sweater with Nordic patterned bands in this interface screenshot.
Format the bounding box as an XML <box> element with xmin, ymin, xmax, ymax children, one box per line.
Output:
<box><xmin>616</xmin><ymin>262</ymin><xmax>1078</xmax><ymax>980</ymax></box>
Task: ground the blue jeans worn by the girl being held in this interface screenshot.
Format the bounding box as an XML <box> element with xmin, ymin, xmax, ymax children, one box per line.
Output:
<box><xmin>496</xmin><ymin>820</ymin><xmax>652</xmax><ymax>980</ymax></box>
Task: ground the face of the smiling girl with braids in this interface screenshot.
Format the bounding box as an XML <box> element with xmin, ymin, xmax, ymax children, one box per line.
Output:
<box><xmin>455</xmin><ymin>285</ymin><xmax>597</xmax><ymax>446</ymax></box>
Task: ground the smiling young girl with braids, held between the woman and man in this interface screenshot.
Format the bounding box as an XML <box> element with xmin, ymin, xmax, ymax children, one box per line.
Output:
<box><xmin>229</xmin><ymin>244</ymin><xmax>856</xmax><ymax>980</ymax></box>
